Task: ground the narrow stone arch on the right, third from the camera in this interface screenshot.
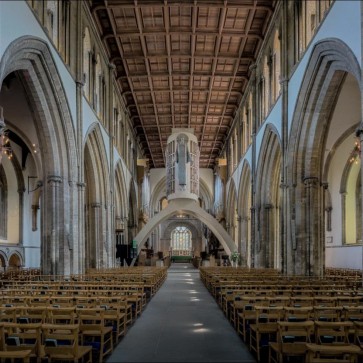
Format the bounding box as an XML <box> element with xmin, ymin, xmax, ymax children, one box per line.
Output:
<box><xmin>237</xmin><ymin>160</ymin><xmax>252</xmax><ymax>267</ymax></box>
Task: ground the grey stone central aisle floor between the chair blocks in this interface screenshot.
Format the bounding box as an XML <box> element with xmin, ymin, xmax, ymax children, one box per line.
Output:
<box><xmin>107</xmin><ymin>263</ymin><xmax>256</xmax><ymax>363</ymax></box>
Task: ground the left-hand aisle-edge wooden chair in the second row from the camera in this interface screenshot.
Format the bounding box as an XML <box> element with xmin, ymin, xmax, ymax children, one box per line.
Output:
<box><xmin>76</xmin><ymin>308</ymin><xmax>113</xmax><ymax>362</ymax></box>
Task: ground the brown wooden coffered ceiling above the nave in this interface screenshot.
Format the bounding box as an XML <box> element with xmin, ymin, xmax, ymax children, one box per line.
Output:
<box><xmin>89</xmin><ymin>0</ymin><xmax>275</xmax><ymax>168</ymax></box>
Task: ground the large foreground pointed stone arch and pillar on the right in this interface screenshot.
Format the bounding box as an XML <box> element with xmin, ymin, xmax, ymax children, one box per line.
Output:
<box><xmin>286</xmin><ymin>39</ymin><xmax>361</xmax><ymax>276</ymax></box>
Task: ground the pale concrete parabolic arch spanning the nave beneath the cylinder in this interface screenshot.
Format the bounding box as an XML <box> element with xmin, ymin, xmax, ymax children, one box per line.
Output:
<box><xmin>134</xmin><ymin>199</ymin><xmax>237</xmax><ymax>254</ymax></box>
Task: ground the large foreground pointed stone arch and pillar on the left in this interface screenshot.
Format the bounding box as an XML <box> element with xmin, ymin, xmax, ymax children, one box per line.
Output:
<box><xmin>0</xmin><ymin>36</ymin><xmax>78</xmax><ymax>274</ymax></box>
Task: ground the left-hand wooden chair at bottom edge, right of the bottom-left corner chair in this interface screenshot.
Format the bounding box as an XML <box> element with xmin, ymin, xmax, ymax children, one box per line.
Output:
<box><xmin>42</xmin><ymin>324</ymin><xmax>92</xmax><ymax>363</ymax></box>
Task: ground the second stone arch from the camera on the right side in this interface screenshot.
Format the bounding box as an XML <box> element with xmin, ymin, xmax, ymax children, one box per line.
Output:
<box><xmin>254</xmin><ymin>124</ymin><xmax>282</xmax><ymax>268</ymax></box>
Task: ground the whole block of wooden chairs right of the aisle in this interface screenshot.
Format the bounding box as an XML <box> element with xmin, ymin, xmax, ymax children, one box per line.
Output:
<box><xmin>201</xmin><ymin>268</ymin><xmax>363</xmax><ymax>363</ymax></box>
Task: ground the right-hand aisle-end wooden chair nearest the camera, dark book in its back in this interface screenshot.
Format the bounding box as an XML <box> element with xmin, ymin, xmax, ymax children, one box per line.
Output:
<box><xmin>269</xmin><ymin>321</ymin><xmax>314</xmax><ymax>363</ymax></box>
